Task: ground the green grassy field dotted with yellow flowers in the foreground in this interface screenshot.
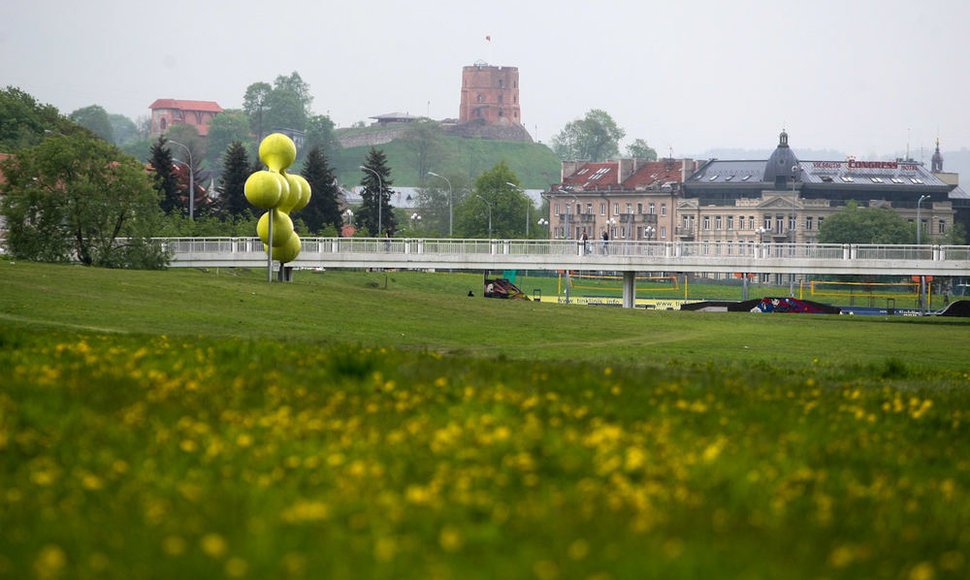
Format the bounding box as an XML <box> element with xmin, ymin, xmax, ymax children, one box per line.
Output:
<box><xmin>0</xmin><ymin>260</ymin><xmax>970</xmax><ymax>579</ymax></box>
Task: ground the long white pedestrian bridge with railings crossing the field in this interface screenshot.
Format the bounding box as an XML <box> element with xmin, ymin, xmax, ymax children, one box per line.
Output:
<box><xmin>156</xmin><ymin>238</ymin><xmax>970</xmax><ymax>276</ymax></box>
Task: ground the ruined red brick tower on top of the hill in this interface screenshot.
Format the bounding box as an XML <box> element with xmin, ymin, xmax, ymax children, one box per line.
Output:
<box><xmin>458</xmin><ymin>61</ymin><xmax>522</xmax><ymax>127</ymax></box>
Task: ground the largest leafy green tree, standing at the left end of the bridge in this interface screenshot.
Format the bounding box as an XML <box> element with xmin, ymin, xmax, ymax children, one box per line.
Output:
<box><xmin>0</xmin><ymin>134</ymin><xmax>167</xmax><ymax>268</ymax></box>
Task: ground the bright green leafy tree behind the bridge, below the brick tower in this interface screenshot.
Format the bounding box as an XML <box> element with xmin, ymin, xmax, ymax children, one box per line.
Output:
<box><xmin>457</xmin><ymin>161</ymin><xmax>532</xmax><ymax>238</ymax></box>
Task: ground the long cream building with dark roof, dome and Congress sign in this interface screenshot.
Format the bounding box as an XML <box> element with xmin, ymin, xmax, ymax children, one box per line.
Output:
<box><xmin>676</xmin><ymin>131</ymin><xmax>970</xmax><ymax>250</ymax></box>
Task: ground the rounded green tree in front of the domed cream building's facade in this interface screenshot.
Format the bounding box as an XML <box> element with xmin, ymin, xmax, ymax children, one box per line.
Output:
<box><xmin>818</xmin><ymin>200</ymin><xmax>916</xmax><ymax>244</ymax></box>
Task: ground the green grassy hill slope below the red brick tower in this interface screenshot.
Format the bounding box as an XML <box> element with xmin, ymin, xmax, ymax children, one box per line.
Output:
<box><xmin>335</xmin><ymin>131</ymin><xmax>560</xmax><ymax>189</ymax></box>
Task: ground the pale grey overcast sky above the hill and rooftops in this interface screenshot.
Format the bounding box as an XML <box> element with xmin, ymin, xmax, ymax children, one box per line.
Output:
<box><xmin>0</xmin><ymin>0</ymin><xmax>970</xmax><ymax>158</ymax></box>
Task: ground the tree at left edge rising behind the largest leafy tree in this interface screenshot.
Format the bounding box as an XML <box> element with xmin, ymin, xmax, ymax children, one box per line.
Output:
<box><xmin>0</xmin><ymin>87</ymin><xmax>78</xmax><ymax>152</ymax></box>
